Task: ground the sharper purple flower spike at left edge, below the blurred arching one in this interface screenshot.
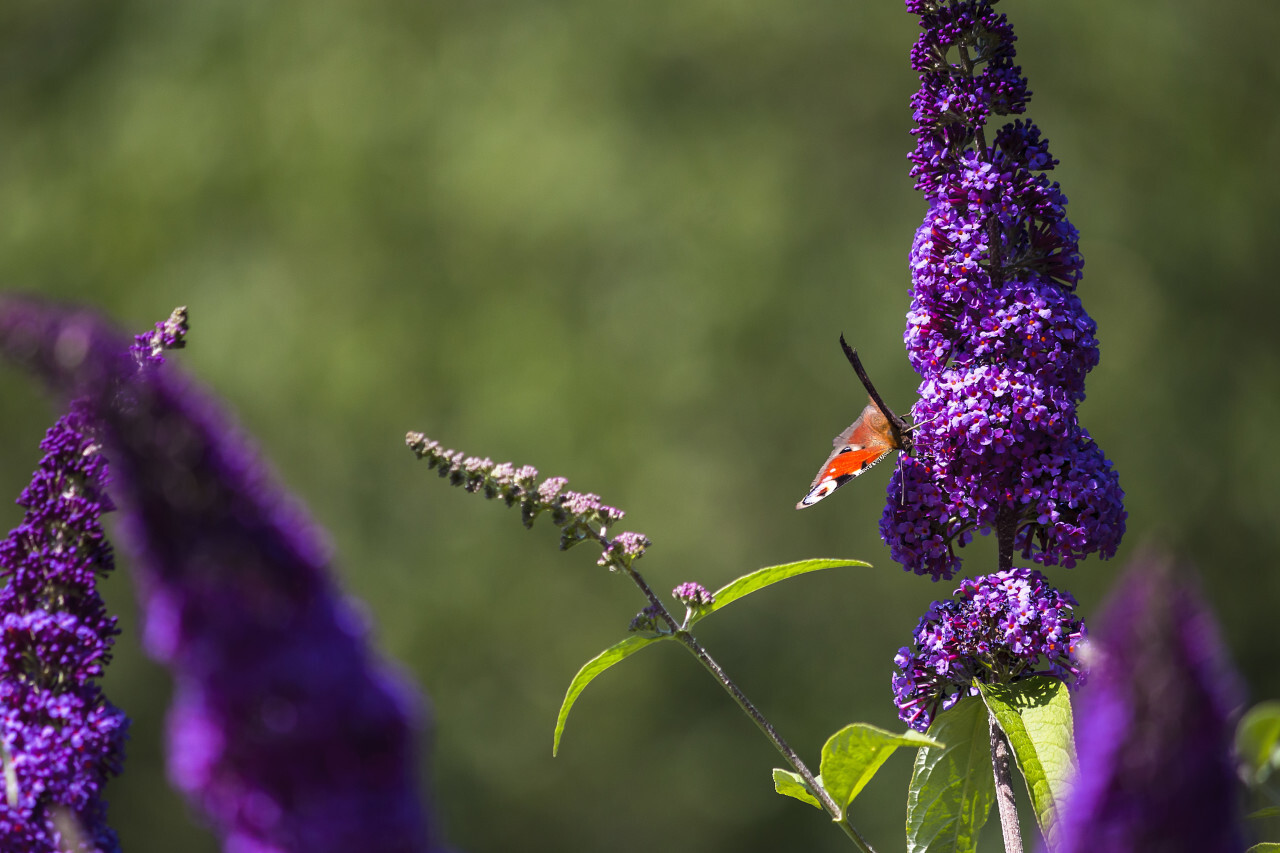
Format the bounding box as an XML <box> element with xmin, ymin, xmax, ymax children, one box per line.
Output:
<box><xmin>0</xmin><ymin>406</ymin><xmax>128</xmax><ymax>853</ymax></box>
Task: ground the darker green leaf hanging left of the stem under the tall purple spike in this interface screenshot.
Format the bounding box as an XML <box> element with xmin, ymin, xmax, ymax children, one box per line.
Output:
<box><xmin>906</xmin><ymin>698</ymin><xmax>996</xmax><ymax>853</ymax></box>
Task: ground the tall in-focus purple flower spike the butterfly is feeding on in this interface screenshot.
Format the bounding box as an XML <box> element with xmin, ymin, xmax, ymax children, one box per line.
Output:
<box><xmin>881</xmin><ymin>0</ymin><xmax>1125</xmax><ymax>580</ymax></box>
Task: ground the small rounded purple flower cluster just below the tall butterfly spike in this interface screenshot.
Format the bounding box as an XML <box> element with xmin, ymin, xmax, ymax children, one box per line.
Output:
<box><xmin>893</xmin><ymin>569</ymin><xmax>1085</xmax><ymax>731</ymax></box>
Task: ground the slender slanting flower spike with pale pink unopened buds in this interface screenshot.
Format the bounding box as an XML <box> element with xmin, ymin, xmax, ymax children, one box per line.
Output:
<box><xmin>404</xmin><ymin>433</ymin><xmax>653</xmax><ymax>571</ymax></box>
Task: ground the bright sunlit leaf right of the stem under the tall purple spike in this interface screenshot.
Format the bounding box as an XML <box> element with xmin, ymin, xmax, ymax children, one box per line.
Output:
<box><xmin>978</xmin><ymin>675</ymin><xmax>1075</xmax><ymax>848</ymax></box>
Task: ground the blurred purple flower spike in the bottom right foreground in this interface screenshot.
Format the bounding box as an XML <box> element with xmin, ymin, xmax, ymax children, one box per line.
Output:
<box><xmin>1056</xmin><ymin>560</ymin><xmax>1245</xmax><ymax>853</ymax></box>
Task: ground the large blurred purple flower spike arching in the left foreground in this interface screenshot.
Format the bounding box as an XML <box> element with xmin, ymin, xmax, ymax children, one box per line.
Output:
<box><xmin>0</xmin><ymin>298</ymin><xmax>439</xmax><ymax>853</ymax></box>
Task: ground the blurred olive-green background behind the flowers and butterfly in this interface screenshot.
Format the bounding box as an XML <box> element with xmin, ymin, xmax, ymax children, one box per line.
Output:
<box><xmin>0</xmin><ymin>0</ymin><xmax>1280</xmax><ymax>853</ymax></box>
